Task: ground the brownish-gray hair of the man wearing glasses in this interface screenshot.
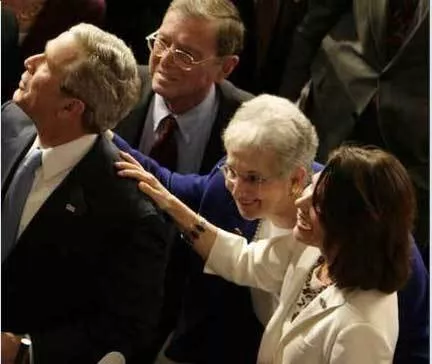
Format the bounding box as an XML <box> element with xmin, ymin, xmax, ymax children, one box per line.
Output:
<box><xmin>167</xmin><ymin>0</ymin><xmax>245</xmax><ymax>57</ymax></box>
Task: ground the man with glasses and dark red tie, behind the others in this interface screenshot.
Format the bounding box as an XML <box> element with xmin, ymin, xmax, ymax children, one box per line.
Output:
<box><xmin>115</xmin><ymin>0</ymin><xmax>252</xmax><ymax>173</ymax></box>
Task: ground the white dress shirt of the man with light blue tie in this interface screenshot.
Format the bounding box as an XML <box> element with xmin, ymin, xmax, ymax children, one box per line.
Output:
<box><xmin>18</xmin><ymin>134</ymin><xmax>97</xmax><ymax>237</ymax></box>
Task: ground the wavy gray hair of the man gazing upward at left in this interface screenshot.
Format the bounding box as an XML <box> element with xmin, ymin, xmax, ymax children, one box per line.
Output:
<box><xmin>61</xmin><ymin>23</ymin><xmax>141</xmax><ymax>132</ymax></box>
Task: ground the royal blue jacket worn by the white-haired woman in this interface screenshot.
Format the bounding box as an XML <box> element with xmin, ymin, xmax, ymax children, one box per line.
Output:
<box><xmin>114</xmin><ymin>137</ymin><xmax>429</xmax><ymax>364</ymax></box>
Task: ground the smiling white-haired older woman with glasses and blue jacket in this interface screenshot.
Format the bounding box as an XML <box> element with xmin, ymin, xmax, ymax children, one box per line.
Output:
<box><xmin>114</xmin><ymin>95</ymin><xmax>318</xmax><ymax>364</ymax></box>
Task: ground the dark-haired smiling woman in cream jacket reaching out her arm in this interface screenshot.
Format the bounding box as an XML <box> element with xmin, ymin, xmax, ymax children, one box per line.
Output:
<box><xmin>120</xmin><ymin>140</ymin><xmax>414</xmax><ymax>364</ymax></box>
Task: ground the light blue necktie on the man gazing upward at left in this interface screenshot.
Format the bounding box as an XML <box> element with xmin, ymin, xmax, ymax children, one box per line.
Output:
<box><xmin>1</xmin><ymin>148</ymin><xmax>42</xmax><ymax>263</ymax></box>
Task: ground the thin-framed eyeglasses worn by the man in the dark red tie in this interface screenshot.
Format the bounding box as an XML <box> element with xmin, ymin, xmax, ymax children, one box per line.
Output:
<box><xmin>146</xmin><ymin>31</ymin><xmax>217</xmax><ymax>71</ymax></box>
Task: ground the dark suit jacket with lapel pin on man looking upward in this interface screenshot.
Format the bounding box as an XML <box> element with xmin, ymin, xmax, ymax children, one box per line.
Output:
<box><xmin>1</xmin><ymin>103</ymin><xmax>174</xmax><ymax>364</ymax></box>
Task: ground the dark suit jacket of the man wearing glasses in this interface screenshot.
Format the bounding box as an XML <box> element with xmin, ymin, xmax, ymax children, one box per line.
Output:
<box><xmin>115</xmin><ymin>66</ymin><xmax>253</xmax><ymax>173</ymax></box>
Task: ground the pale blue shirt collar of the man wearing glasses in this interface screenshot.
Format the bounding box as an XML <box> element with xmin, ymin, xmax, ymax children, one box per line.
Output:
<box><xmin>153</xmin><ymin>84</ymin><xmax>217</xmax><ymax>143</ymax></box>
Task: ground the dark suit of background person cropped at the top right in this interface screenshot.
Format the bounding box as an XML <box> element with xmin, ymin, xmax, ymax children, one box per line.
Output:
<box><xmin>281</xmin><ymin>0</ymin><xmax>430</xmax><ymax>267</ymax></box>
